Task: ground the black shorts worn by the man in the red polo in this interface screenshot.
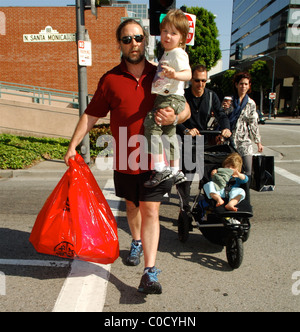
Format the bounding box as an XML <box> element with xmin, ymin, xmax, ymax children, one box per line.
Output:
<box><xmin>114</xmin><ymin>171</ymin><xmax>174</xmax><ymax>207</ymax></box>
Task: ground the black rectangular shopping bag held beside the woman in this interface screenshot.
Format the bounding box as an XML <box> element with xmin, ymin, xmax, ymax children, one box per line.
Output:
<box><xmin>251</xmin><ymin>155</ymin><xmax>275</xmax><ymax>191</ymax></box>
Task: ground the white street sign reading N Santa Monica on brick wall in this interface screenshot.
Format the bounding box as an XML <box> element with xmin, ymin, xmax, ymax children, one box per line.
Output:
<box><xmin>23</xmin><ymin>26</ymin><xmax>76</xmax><ymax>43</ymax></box>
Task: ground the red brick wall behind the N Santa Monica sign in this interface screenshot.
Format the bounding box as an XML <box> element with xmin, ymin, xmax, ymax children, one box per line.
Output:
<box><xmin>0</xmin><ymin>7</ymin><xmax>127</xmax><ymax>93</ymax></box>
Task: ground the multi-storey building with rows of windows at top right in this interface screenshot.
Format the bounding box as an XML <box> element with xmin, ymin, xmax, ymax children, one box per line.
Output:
<box><xmin>231</xmin><ymin>0</ymin><xmax>300</xmax><ymax>109</ymax></box>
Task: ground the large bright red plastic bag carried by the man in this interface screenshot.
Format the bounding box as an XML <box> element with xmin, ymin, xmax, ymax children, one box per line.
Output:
<box><xmin>29</xmin><ymin>154</ymin><xmax>119</xmax><ymax>264</ymax></box>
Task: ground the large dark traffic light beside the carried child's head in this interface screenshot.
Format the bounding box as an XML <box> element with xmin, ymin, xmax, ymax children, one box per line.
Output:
<box><xmin>149</xmin><ymin>0</ymin><xmax>176</xmax><ymax>36</ymax></box>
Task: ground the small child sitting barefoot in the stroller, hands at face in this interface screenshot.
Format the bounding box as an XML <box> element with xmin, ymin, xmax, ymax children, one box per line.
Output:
<box><xmin>203</xmin><ymin>153</ymin><xmax>249</xmax><ymax>212</ymax></box>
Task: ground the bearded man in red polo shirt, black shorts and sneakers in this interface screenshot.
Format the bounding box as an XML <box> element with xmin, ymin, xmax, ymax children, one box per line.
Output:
<box><xmin>65</xmin><ymin>19</ymin><xmax>190</xmax><ymax>294</ymax></box>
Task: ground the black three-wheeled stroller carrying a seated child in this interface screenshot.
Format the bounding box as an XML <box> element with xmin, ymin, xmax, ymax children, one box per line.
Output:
<box><xmin>178</xmin><ymin>131</ymin><xmax>253</xmax><ymax>269</ymax></box>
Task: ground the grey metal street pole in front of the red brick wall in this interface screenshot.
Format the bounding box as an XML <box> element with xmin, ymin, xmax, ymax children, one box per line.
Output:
<box><xmin>76</xmin><ymin>0</ymin><xmax>91</xmax><ymax>164</ymax></box>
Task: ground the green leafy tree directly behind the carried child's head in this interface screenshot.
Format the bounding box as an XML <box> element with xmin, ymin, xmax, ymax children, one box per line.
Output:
<box><xmin>187</xmin><ymin>7</ymin><xmax>222</xmax><ymax>70</ymax></box>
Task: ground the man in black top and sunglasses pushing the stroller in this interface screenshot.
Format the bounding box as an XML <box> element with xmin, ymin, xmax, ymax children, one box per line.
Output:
<box><xmin>177</xmin><ymin>65</ymin><xmax>231</xmax><ymax>212</ymax></box>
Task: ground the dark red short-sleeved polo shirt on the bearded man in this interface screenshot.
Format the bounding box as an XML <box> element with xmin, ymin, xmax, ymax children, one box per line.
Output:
<box><xmin>85</xmin><ymin>60</ymin><xmax>156</xmax><ymax>174</ymax></box>
